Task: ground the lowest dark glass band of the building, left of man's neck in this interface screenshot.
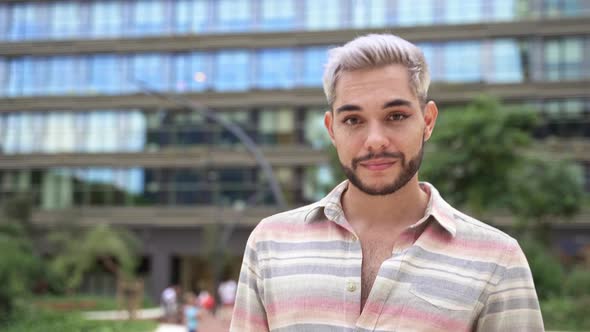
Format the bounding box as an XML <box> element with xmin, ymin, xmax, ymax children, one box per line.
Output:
<box><xmin>0</xmin><ymin>167</ymin><xmax>301</xmax><ymax>210</ymax></box>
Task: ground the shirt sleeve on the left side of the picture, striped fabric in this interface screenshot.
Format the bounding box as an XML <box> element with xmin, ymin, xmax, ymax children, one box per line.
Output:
<box><xmin>230</xmin><ymin>231</ymin><xmax>269</xmax><ymax>332</ymax></box>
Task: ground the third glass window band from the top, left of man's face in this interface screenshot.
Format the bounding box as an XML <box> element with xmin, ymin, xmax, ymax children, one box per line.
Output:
<box><xmin>0</xmin><ymin>108</ymin><xmax>329</xmax><ymax>155</ymax></box>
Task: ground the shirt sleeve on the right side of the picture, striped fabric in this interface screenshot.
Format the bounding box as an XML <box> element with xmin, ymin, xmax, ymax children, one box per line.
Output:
<box><xmin>476</xmin><ymin>241</ymin><xmax>544</xmax><ymax>332</ymax></box>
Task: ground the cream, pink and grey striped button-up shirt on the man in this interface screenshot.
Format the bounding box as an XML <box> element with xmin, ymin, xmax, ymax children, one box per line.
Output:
<box><xmin>230</xmin><ymin>181</ymin><xmax>543</xmax><ymax>332</ymax></box>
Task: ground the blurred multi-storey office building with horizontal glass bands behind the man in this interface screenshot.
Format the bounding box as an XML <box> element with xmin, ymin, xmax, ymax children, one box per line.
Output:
<box><xmin>0</xmin><ymin>0</ymin><xmax>590</xmax><ymax>294</ymax></box>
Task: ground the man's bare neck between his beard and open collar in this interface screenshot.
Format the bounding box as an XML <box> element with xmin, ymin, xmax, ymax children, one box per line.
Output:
<box><xmin>341</xmin><ymin>176</ymin><xmax>429</xmax><ymax>233</ymax></box>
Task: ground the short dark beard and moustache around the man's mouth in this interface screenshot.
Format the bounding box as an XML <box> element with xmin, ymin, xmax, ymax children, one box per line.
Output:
<box><xmin>340</xmin><ymin>139</ymin><xmax>424</xmax><ymax>196</ymax></box>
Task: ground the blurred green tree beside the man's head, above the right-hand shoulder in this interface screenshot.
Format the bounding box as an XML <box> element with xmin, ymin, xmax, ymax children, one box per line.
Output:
<box><xmin>421</xmin><ymin>97</ymin><xmax>583</xmax><ymax>232</ymax></box>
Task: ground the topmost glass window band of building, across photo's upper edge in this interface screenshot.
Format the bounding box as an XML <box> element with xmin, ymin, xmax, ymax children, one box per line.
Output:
<box><xmin>0</xmin><ymin>0</ymin><xmax>590</xmax><ymax>40</ymax></box>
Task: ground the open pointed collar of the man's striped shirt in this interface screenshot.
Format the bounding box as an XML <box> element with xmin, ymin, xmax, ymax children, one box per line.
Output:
<box><xmin>305</xmin><ymin>180</ymin><xmax>457</xmax><ymax>237</ymax></box>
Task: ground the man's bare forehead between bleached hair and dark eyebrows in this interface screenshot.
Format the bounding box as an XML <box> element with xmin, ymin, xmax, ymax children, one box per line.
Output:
<box><xmin>334</xmin><ymin>65</ymin><xmax>418</xmax><ymax>107</ymax></box>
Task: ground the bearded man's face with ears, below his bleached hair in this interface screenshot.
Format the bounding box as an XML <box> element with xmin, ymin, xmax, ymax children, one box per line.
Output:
<box><xmin>324</xmin><ymin>65</ymin><xmax>438</xmax><ymax>195</ymax></box>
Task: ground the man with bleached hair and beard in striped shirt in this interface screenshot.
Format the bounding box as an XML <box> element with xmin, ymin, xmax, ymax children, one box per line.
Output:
<box><xmin>231</xmin><ymin>35</ymin><xmax>543</xmax><ymax>332</ymax></box>
